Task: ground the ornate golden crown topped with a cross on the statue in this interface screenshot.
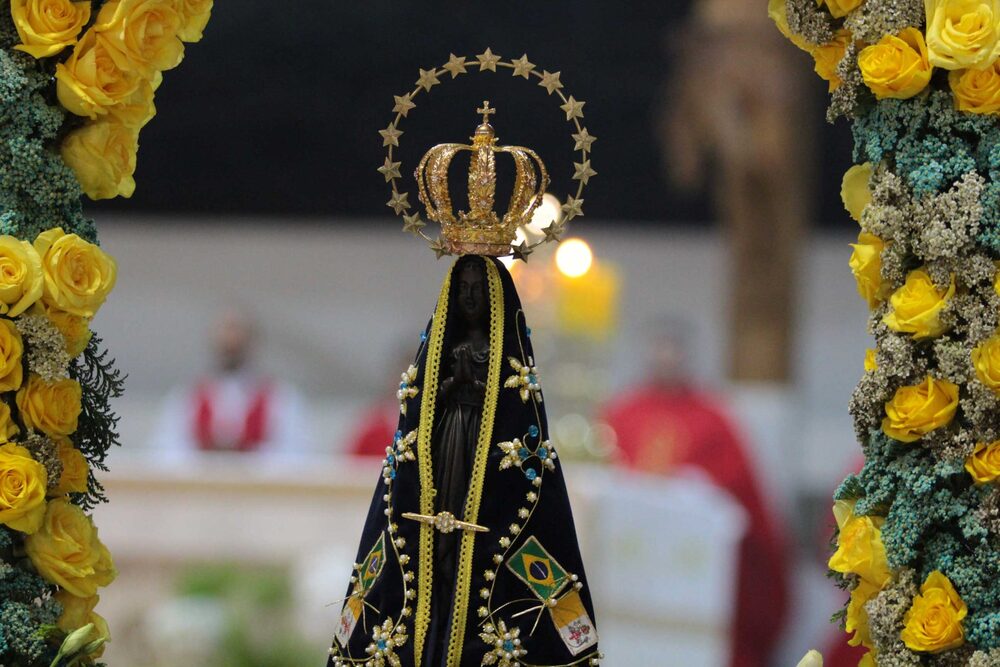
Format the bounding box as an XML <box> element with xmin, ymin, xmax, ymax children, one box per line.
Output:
<box><xmin>414</xmin><ymin>101</ymin><xmax>549</xmax><ymax>256</ymax></box>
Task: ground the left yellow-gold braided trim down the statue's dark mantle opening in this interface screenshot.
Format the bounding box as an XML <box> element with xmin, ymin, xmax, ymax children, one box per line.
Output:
<box><xmin>413</xmin><ymin>267</ymin><xmax>454</xmax><ymax>667</ymax></box>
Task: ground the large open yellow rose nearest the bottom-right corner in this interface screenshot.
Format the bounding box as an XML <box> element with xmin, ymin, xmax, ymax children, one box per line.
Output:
<box><xmin>899</xmin><ymin>570</ymin><xmax>969</xmax><ymax>653</ymax></box>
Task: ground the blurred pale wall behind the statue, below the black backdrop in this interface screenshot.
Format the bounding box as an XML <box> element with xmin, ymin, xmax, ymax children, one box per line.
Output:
<box><xmin>95</xmin><ymin>218</ymin><xmax>869</xmax><ymax>496</ymax></box>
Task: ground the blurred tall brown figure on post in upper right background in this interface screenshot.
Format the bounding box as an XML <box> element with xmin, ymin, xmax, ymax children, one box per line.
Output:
<box><xmin>660</xmin><ymin>0</ymin><xmax>810</xmax><ymax>382</ymax></box>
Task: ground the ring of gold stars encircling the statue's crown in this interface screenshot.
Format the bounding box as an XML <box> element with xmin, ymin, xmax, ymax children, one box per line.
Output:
<box><xmin>378</xmin><ymin>49</ymin><xmax>597</xmax><ymax>261</ymax></box>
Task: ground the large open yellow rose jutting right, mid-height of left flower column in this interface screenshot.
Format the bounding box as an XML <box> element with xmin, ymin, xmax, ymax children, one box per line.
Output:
<box><xmin>35</xmin><ymin>227</ymin><xmax>118</xmax><ymax>317</ymax></box>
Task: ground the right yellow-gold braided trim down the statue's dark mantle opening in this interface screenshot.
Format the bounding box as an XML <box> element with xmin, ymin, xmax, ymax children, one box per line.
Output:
<box><xmin>446</xmin><ymin>260</ymin><xmax>504</xmax><ymax>667</ymax></box>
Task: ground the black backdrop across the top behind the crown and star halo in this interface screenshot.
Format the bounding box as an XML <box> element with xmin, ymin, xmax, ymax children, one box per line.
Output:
<box><xmin>93</xmin><ymin>0</ymin><xmax>850</xmax><ymax>225</ymax></box>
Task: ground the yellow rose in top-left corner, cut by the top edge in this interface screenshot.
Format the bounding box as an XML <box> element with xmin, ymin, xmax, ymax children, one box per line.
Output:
<box><xmin>10</xmin><ymin>0</ymin><xmax>90</xmax><ymax>58</ymax></box>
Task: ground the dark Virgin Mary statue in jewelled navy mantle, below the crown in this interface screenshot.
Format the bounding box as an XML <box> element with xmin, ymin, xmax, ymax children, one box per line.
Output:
<box><xmin>328</xmin><ymin>255</ymin><xmax>600</xmax><ymax>667</ymax></box>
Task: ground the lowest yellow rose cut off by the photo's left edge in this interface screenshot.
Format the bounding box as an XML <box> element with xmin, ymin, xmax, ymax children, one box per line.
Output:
<box><xmin>0</xmin><ymin>443</ymin><xmax>48</xmax><ymax>535</ymax></box>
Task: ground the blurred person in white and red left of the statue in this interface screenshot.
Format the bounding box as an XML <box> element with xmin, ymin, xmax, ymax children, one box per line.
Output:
<box><xmin>154</xmin><ymin>309</ymin><xmax>308</xmax><ymax>457</ymax></box>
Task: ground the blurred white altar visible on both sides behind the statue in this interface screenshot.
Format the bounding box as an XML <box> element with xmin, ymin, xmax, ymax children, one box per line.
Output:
<box><xmin>96</xmin><ymin>455</ymin><xmax>743</xmax><ymax>667</ymax></box>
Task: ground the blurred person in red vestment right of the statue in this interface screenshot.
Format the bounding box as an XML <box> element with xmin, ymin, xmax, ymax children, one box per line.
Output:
<box><xmin>603</xmin><ymin>322</ymin><xmax>789</xmax><ymax>667</ymax></box>
